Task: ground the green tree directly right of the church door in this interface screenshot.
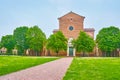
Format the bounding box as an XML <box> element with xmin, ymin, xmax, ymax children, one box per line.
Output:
<box><xmin>73</xmin><ymin>31</ymin><xmax>95</xmax><ymax>55</ymax></box>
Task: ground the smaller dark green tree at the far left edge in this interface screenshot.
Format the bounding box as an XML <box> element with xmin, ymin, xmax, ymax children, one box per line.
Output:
<box><xmin>1</xmin><ymin>35</ymin><xmax>16</xmax><ymax>53</ymax></box>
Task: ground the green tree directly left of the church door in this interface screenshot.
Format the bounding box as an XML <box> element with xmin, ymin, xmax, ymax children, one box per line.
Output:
<box><xmin>47</xmin><ymin>31</ymin><xmax>67</xmax><ymax>55</ymax></box>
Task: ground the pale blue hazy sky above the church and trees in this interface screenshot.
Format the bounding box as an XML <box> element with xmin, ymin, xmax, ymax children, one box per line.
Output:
<box><xmin>0</xmin><ymin>0</ymin><xmax>120</xmax><ymax>38</ymax></box>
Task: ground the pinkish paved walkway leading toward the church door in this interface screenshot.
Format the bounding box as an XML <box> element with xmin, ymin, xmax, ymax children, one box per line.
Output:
<box><xmin>0</xmin><ymin>57</ymin><xmax>73</xmax><ymax>80</ymax></box>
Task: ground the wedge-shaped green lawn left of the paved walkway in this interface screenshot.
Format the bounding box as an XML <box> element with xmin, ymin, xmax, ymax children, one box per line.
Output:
<box><xmin>0</xmin><ymin>56</ymin><xmax>58</xmax><ymax>75</ymax></box>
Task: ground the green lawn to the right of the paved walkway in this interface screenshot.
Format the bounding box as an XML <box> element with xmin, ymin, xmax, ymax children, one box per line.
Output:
<box><xmin>63</xmin><ymin>58</ymin><xmax>120</xmax><ymax>80</ymax></box>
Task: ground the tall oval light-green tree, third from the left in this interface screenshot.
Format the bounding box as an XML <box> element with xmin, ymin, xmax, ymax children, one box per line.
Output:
<box><xmin>26</xmin><ymin>26</ymin><xmax>46</xmax><ymax>55</ymax></box>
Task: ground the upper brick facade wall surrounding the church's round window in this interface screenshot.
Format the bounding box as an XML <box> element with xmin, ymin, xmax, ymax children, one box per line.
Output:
<box><xmin>59</xmin><ymin>13</ymin><xmax>84</xmax><ymax>39</ymax></box>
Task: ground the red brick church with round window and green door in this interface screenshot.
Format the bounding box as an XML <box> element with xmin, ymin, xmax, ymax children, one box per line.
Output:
<box><xmin>53</xmin><ymin>11</ymin><xmax>95</xmax><ymax>56</ymax></box>
